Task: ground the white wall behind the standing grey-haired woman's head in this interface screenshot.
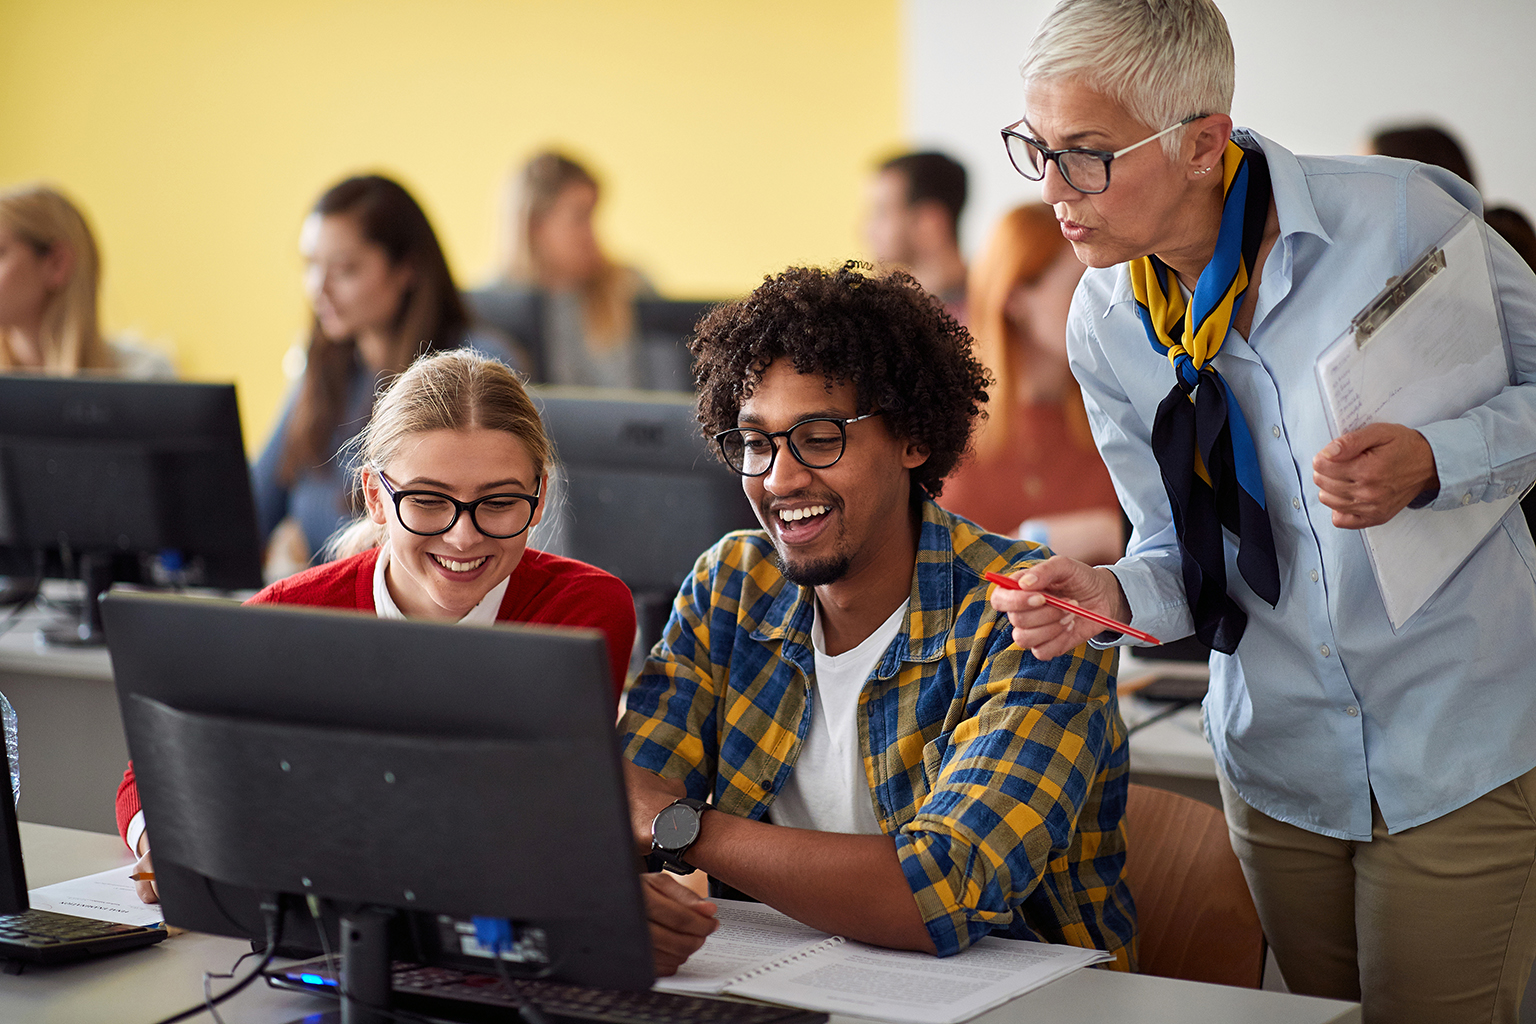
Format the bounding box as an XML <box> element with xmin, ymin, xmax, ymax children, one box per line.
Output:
<box><xmin>903</xmin><ymin>0</ymin><xmax>1536</xmax><ymax>252</ymax></box>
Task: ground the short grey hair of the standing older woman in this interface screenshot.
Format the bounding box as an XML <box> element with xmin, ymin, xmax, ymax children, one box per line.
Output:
<box><xmin>1018</xmin><ymin>0</ymin><xmax>1235</xmax><ymax>157</ymax></box>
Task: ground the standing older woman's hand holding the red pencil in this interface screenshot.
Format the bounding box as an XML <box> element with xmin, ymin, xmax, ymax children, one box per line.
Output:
<box><xmin>992</xmin><ymin>554</ymin><xmax>1130</xmax><ymax>662</ymax></box>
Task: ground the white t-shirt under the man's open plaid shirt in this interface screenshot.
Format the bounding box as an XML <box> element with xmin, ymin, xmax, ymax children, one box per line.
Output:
<box><xmin>768</xmin><ymin>600</ymin><xmax>911</xmax><ymax>835</ymax></box>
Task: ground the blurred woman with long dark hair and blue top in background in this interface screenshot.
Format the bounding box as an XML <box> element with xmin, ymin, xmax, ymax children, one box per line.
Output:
<box><xmin>252</xmin><ymin>175</ymin><xmax>515</xmax><ymax>568</ymax></box>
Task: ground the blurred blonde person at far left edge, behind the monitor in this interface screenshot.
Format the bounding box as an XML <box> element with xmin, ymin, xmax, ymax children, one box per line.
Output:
<box><xmin>0</xmin><ymin>186</ymin><xmax>175</xmax><ymax>378</ymax></box>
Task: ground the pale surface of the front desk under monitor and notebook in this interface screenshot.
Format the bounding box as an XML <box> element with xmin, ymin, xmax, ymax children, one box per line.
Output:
<box><xmin>0</xmin><ymin>823</ymin><xmax>1359</xmax><ymax>1024</ymax></box>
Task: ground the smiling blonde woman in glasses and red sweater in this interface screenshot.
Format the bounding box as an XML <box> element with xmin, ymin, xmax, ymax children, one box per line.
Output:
<box><xmin>117</xmin><ymin>350</ymin><xmax>634</xmax><ymax>901</ymax></box>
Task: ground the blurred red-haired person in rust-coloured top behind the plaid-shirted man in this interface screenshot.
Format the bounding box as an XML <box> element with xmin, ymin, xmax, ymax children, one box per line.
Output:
<box><xmin>943</xmin><ymin>203</ymin><xmax>1126</xmax><ymax>565</ymax></box>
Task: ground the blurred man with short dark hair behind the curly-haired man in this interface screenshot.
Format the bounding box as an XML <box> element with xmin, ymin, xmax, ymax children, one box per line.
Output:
<box><xmin>865</xmin><ymin>152</ymin><xmax>966</xmax><ymax>322</ymax></box>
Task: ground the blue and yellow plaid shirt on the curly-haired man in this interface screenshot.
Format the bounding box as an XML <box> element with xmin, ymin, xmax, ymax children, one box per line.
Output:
<box><xmin>621</xmin><ymin>500</ymin><xmax>1135</xmax><ymax>969</ymax></box>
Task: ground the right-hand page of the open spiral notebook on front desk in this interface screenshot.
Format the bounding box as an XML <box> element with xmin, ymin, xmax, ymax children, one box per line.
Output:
<box><xmin>730</xmin><ymin>936</ymin><xmax>1112</xmax><ymax>1024</ymax></box>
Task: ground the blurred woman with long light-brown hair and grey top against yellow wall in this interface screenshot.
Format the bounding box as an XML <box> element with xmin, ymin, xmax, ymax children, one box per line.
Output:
<box><xmin>468</xmin><ymin>152</ymin><xmax>656</xmax><ymax>387</ymax></box>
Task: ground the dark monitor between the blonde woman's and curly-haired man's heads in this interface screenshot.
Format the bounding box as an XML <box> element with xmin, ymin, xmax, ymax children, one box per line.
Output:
<box><xmin>533</xmin><ymin>387</ymin><xmax>759</xmax><ymax>648</ymax></box>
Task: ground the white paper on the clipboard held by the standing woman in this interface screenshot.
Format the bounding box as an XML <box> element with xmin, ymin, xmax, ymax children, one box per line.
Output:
<box><xmin>1316</xmin><ymin>213</ymin><xmax>1519</xmax><ymax>629</ymax></box>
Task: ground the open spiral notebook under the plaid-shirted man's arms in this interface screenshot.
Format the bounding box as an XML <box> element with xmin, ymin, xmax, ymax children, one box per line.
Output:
<box><xmin>656</xmin><ymin>900</ymin><xmax>1112</xmax><ymax>1024</ymax></box>
